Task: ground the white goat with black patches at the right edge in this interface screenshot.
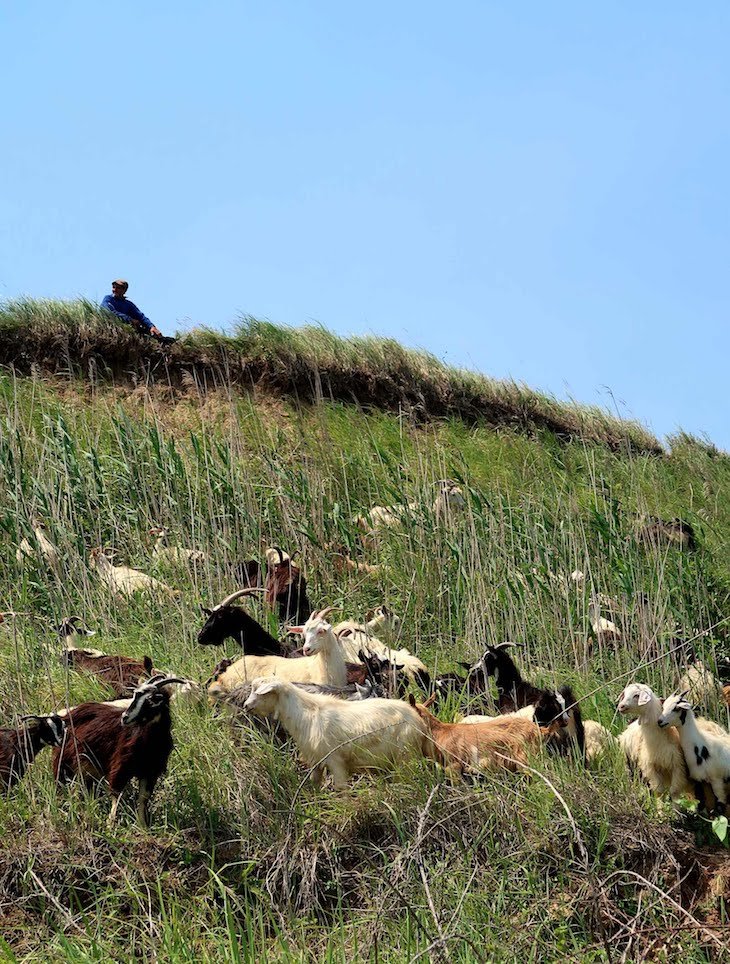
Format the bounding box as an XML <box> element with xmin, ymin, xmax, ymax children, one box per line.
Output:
<box><xmin>657</xmin><ymin>693</ymin><xmax>730</xmax><ymax>813</ymax></box>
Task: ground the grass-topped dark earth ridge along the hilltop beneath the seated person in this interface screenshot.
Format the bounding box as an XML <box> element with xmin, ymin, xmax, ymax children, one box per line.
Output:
<box><xmin>0</xmin><ymin>300</ymin><xmax>662</xmax><ymax>454</ymax></box>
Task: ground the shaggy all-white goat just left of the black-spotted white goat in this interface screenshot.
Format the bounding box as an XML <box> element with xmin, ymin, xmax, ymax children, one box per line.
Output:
<box><xmin>617</xmin><ymin>683</ymin><xmax>695</xmax><ymax>800</ymax></box>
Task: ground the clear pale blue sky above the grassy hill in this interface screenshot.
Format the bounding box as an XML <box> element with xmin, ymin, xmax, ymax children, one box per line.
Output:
<box><xmin>0</xmin><ymin>0</ymin><xmax>730</xmax><ymax>449</ymax></box>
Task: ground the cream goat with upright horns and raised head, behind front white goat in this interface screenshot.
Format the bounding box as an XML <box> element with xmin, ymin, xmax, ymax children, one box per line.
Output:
<box><xmin>208</xmin><ymin>607</ymin><xmax>347</xmax><ymax>696</ymax></box>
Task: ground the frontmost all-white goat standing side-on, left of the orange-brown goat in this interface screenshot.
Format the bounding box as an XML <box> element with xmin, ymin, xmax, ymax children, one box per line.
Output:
<box><xmin>244</xmin><ymin>677</ymin><xmax>427</xmax><ymax>788</ymax></box>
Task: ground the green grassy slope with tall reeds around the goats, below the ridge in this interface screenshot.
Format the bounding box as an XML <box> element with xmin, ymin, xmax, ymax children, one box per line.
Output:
<box><xmin>0</xmin><ymin>330</ymin><xmax>730</xmax><ymax>962</ymax></box>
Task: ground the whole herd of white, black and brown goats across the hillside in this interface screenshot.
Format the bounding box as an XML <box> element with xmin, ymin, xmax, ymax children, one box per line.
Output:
<box><xmin>0</xmin><ymin>500</ymin><xmax>730</xmax><ymax>827</ymax></box>
